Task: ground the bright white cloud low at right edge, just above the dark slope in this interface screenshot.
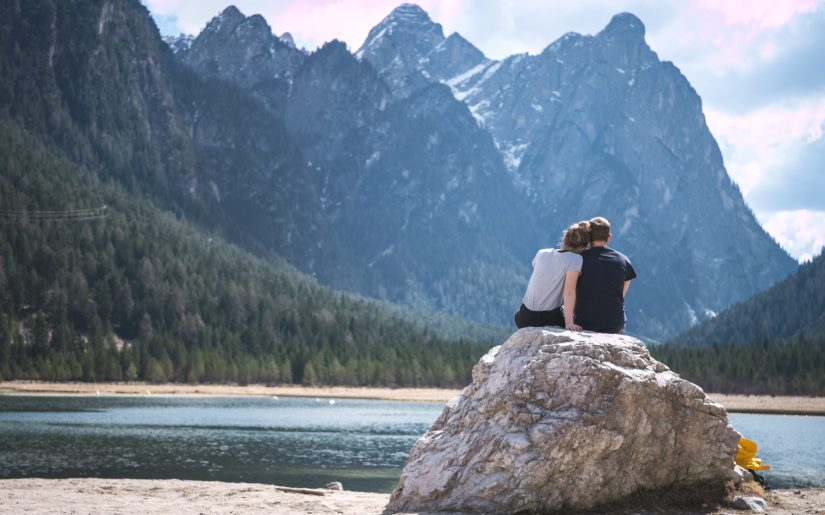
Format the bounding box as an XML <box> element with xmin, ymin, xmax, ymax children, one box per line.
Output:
<box><xmin>762</xmin><ymin>209</ymin><xmax>825</xmax><ymax>262</ymax></box>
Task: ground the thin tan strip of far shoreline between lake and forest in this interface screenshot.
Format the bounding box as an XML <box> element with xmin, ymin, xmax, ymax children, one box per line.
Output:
<box><xmin>0</xmin><ymin>380</ymin><xmax>825</xmax><ymax>416</ymax></box>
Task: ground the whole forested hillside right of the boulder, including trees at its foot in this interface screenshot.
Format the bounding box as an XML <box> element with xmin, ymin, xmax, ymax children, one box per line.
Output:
<box><xmin>651</xmin><ymin>254</ymin><xmax>825</xmax><ymax>395</ymax></box>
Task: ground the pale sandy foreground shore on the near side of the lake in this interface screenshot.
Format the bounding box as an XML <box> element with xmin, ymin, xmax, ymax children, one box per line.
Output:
<box><xmin>0</xmin><ymin>478</ymin><xmax>825</xmax><ymax>515</ymax></box>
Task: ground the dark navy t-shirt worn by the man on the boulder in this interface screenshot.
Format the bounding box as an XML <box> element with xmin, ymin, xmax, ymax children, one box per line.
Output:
<box><xmin>576</xmin><ymin>247</ymin><xmax>636</xmax><ymax>332</ymax></box>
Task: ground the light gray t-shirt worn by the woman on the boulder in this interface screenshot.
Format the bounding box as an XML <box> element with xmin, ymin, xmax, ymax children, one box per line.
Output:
<box><xmin>524</xmin><ymin>249</ymin><xmax>582</xmax><ymax>311</ymax></box>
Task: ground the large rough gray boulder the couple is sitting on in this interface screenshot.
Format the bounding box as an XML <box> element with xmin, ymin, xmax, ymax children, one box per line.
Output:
<box><xmin>387</xmin><ymin>329</ymin><xmax>739</xmax><ymax>512</ymax></box>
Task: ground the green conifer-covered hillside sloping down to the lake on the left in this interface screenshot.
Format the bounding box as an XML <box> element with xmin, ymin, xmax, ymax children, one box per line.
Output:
<box><xmin>0</xmin><ymin>120</ymin><xmax>489</xmax><ymax>386</ymax></box>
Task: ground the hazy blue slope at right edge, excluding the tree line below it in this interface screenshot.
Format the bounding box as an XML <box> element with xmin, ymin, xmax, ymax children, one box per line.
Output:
<box><xmin>669</xmin><ymin>250</ymin><xmax>825</xmax><ymax>345</ymax></box>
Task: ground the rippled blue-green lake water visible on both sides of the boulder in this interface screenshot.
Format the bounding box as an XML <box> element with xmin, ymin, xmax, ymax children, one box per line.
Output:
<box><xmin>0</xmin><ymin>396</ymin><xmax>825</xmax><ymax>492</ymax></box>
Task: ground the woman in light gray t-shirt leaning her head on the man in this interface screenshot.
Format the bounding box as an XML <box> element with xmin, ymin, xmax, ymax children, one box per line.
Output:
<box><xmin>515</xmin><ymin>222</ymin><xmax>590</xmax><ymax>331</ymax></box>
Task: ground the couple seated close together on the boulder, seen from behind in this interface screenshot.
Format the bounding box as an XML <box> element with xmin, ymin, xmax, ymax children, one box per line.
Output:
<box><xmin>515</xmin><ymin>217</ymin><xmax>636</xmax><ymax>333</ymax></box>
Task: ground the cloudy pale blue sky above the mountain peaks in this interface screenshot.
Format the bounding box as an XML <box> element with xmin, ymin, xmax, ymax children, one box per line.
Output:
<box><xmin>143</xmin><ymin>0</ymin><xmax>825</xmax><ymax>261</ymax></box>
